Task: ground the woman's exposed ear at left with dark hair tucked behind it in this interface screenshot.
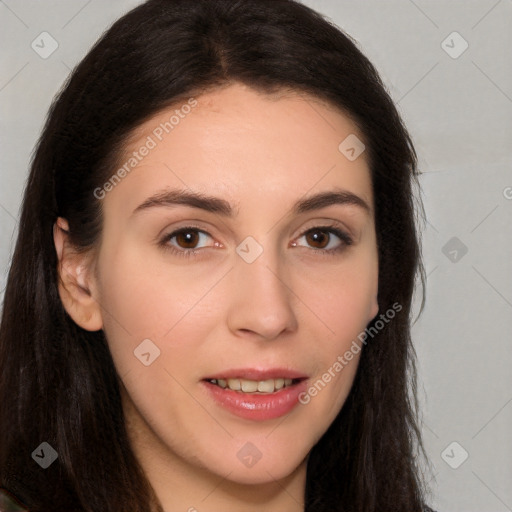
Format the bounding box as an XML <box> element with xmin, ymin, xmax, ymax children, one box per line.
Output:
<box><xmin>53</xmin><ymin>217</ymin><xmax>103</xmax><ymax>331</ymax></box>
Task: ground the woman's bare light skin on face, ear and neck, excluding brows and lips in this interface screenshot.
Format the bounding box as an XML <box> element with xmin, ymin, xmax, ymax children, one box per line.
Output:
<box><xmin>54</xmin><ymin>83</ymin><xmax>378</xmax><ymax>512</ymax></box>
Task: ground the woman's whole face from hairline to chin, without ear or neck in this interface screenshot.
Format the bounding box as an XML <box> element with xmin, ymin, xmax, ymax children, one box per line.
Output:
<box><xmin>80</xmin><ymin>84</ymin><xmax>378</xmax><ymax>483</ymax></box>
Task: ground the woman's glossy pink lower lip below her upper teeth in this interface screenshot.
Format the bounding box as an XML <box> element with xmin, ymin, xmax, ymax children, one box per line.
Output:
<box><xmin>203</xmin><ymin>380</ymin><xmax>307</xmax><ymax>421</ymax></box>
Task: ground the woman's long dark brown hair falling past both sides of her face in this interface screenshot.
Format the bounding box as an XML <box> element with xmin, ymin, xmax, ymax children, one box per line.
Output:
<box><xmin>0</xmin><ymin>0</ymin><xmax>423</xmax><ymax>512</ymax></box>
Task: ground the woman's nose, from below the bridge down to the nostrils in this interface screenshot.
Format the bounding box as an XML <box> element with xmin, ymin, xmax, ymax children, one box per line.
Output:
<box><xmin>227</xmin><ymin>250</ymin><xmax>298</xmax><ymax>340</ymax></box>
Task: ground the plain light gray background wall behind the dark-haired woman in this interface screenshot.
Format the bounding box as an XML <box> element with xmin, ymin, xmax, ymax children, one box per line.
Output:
<box><xmin>0</xmin><ymin>0</ymin><xmax>512</xmax><ymax>512</ymax></box>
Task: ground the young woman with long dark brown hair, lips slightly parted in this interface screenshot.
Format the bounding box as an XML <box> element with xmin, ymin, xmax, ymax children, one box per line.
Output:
<box><xmin>0</xmin><ymin>0</ymin><xmax>428</xmax><ymax>512</ymax></box>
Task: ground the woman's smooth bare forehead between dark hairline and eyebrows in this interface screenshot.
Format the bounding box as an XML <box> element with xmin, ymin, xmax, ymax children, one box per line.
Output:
<box><xmin>107</xmin><ymin>84</ymin><xmax>372</xmax><ymax>218</ymax></box>
